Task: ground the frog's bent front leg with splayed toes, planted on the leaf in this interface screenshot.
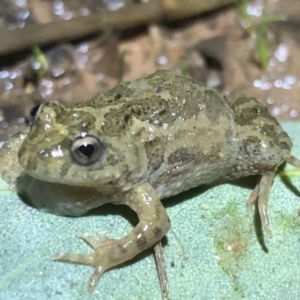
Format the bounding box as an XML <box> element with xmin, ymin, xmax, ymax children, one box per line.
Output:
<box><xmin>52</xmin><ymin>183</ymin><xmax>170</xmax><ymax>292</ymax></box>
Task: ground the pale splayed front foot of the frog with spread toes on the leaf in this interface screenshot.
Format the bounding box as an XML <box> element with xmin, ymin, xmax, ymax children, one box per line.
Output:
<box><xmin>51</xmin><ymin>233</ymin><xmax>122</xmax><ymax>292</ymax></box>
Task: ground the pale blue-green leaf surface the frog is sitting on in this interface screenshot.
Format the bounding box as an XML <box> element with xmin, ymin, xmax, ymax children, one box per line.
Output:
<box><xmin>0</xmin><ymin>123</ymin><xmax>300</xmax><ymax>300</ymax></box>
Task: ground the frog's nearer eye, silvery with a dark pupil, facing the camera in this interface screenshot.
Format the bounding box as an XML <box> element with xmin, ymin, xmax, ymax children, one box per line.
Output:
<box><xmin>70</xmin><ymin>135</ymin><xmax>104</xmax><ymax>166</ymax></box>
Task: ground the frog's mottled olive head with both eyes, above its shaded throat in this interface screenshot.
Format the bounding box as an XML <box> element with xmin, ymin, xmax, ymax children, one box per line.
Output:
<box><xmin>19</xmin><ymin>101</ymin><xmax>145</xmax><ymax>191</ymax></box>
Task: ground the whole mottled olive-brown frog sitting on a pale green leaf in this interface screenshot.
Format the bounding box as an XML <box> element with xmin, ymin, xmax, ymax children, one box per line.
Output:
<box><xmin>0</xmin><ymin>70</ymin><xmax>300</xmax><ymax>292</ymax></box>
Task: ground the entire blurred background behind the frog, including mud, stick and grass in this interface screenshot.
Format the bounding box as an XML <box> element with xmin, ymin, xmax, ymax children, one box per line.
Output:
<box><xmin>0</xmin><ymin>0</ymin><xmax>300</xmax><ymax>140</ymax></box>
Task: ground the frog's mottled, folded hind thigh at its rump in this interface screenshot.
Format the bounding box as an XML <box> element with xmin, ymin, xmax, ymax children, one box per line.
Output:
<box><xmin>232</xmin><ymin>95</ymin><xmax>292</xmax><ymax>169</ymax></box>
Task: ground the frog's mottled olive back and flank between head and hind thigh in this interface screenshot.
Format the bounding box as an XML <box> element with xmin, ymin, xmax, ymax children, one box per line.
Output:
<box><xmin>78</xmin><ymin>71</ymin><xmax>236</xmax><ymax>197</ymax></box>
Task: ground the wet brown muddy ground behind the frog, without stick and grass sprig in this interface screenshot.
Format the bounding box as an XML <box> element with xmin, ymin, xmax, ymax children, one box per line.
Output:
<box><xmin>0</xmin><ymin>0</ymin><xmax>300</xmax><ymax>140</ymax></box>
